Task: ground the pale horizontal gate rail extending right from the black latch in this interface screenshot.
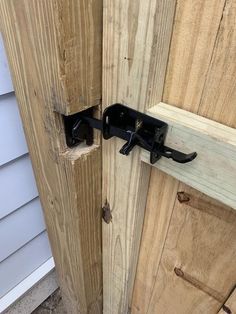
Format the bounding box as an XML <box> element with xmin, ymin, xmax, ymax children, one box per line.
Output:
<box><xmin>141</xmin><ymin>103</ymin><xmax>236</xmax><ymax>209</ymax></box>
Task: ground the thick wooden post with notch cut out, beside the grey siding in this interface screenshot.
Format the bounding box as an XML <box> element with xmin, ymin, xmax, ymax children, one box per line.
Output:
<box><xmin>0</xmin><ymin>0</ymin><xmax>102</xmax><ymax>314</ymax></box>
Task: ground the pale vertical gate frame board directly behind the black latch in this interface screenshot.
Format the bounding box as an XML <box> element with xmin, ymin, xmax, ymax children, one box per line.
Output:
<box><xmin>103</xmin><ymin>0</ymin><xmax>175</xmax><ymax>314</ymax></box>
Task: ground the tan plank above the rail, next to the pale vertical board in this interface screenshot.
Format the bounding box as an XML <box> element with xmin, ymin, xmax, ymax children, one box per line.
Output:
<box><xmin>163</xmin><ymin>0</ymin><xmax>225</xmax><ymax>112</ymax></box>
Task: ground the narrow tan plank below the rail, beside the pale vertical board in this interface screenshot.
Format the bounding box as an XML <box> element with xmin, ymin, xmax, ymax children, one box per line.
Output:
<box><xmin>131</xmin><ymin>169</ymin><xmax>179</xmax><ymax>314</ymax></box>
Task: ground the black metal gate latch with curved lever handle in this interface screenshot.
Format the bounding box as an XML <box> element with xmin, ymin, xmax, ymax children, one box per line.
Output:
<box><xmin>64</xmin><ymin>104</ymin><xmax>197</xmax><ymax>164</ymax></box>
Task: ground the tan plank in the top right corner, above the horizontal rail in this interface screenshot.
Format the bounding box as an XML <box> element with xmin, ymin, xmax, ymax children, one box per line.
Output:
<box><xmin>198</xmin><ymin>0</ymin><xmax>236</xmax><ymax>128</ymax></box>
